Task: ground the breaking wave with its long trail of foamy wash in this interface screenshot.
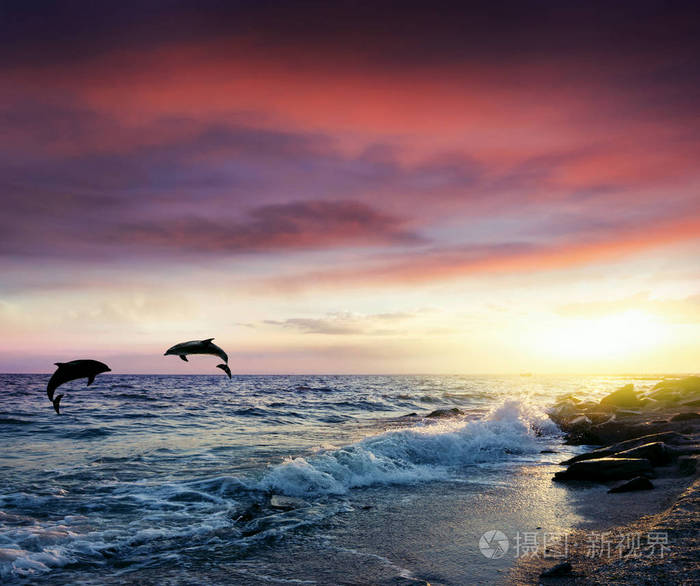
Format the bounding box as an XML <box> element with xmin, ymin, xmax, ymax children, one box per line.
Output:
<box><xmin>0</xmin><ymin>401</ymin><xmax>557</xmax><ymax>581</ymax></box>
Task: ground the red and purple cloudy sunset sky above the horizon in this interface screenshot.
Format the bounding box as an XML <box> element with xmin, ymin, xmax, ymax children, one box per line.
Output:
<box><xmin>0</xmin><ymin>0</ymin><xmax>700</xmax><ymax>374</ymax></box>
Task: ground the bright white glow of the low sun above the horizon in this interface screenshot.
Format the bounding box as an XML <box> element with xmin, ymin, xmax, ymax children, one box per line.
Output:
<box><xmin>535</xmin><ymin>310</ymin><xmax>669</xmax><ymax>359</ymax></box>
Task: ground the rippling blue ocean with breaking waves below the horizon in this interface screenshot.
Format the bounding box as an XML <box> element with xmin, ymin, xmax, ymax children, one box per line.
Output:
<box><xmin>0</xmin><ymin>374</ymin><xmax>657</xmax><ymax>585</ymax></box>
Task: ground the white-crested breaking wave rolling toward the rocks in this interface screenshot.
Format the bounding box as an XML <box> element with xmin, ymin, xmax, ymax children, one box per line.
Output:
<box><xmin>259</xmin><ymin>400</ymin><xmax>558</xmax><ymax>497</ymax></box>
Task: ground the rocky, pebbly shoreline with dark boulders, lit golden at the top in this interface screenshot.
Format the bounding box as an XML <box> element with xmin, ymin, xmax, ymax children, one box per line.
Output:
<box><xmin>509</xmin><ymin>376</ymin><xmax>700</xmax><ymax>584</ymax></box>
